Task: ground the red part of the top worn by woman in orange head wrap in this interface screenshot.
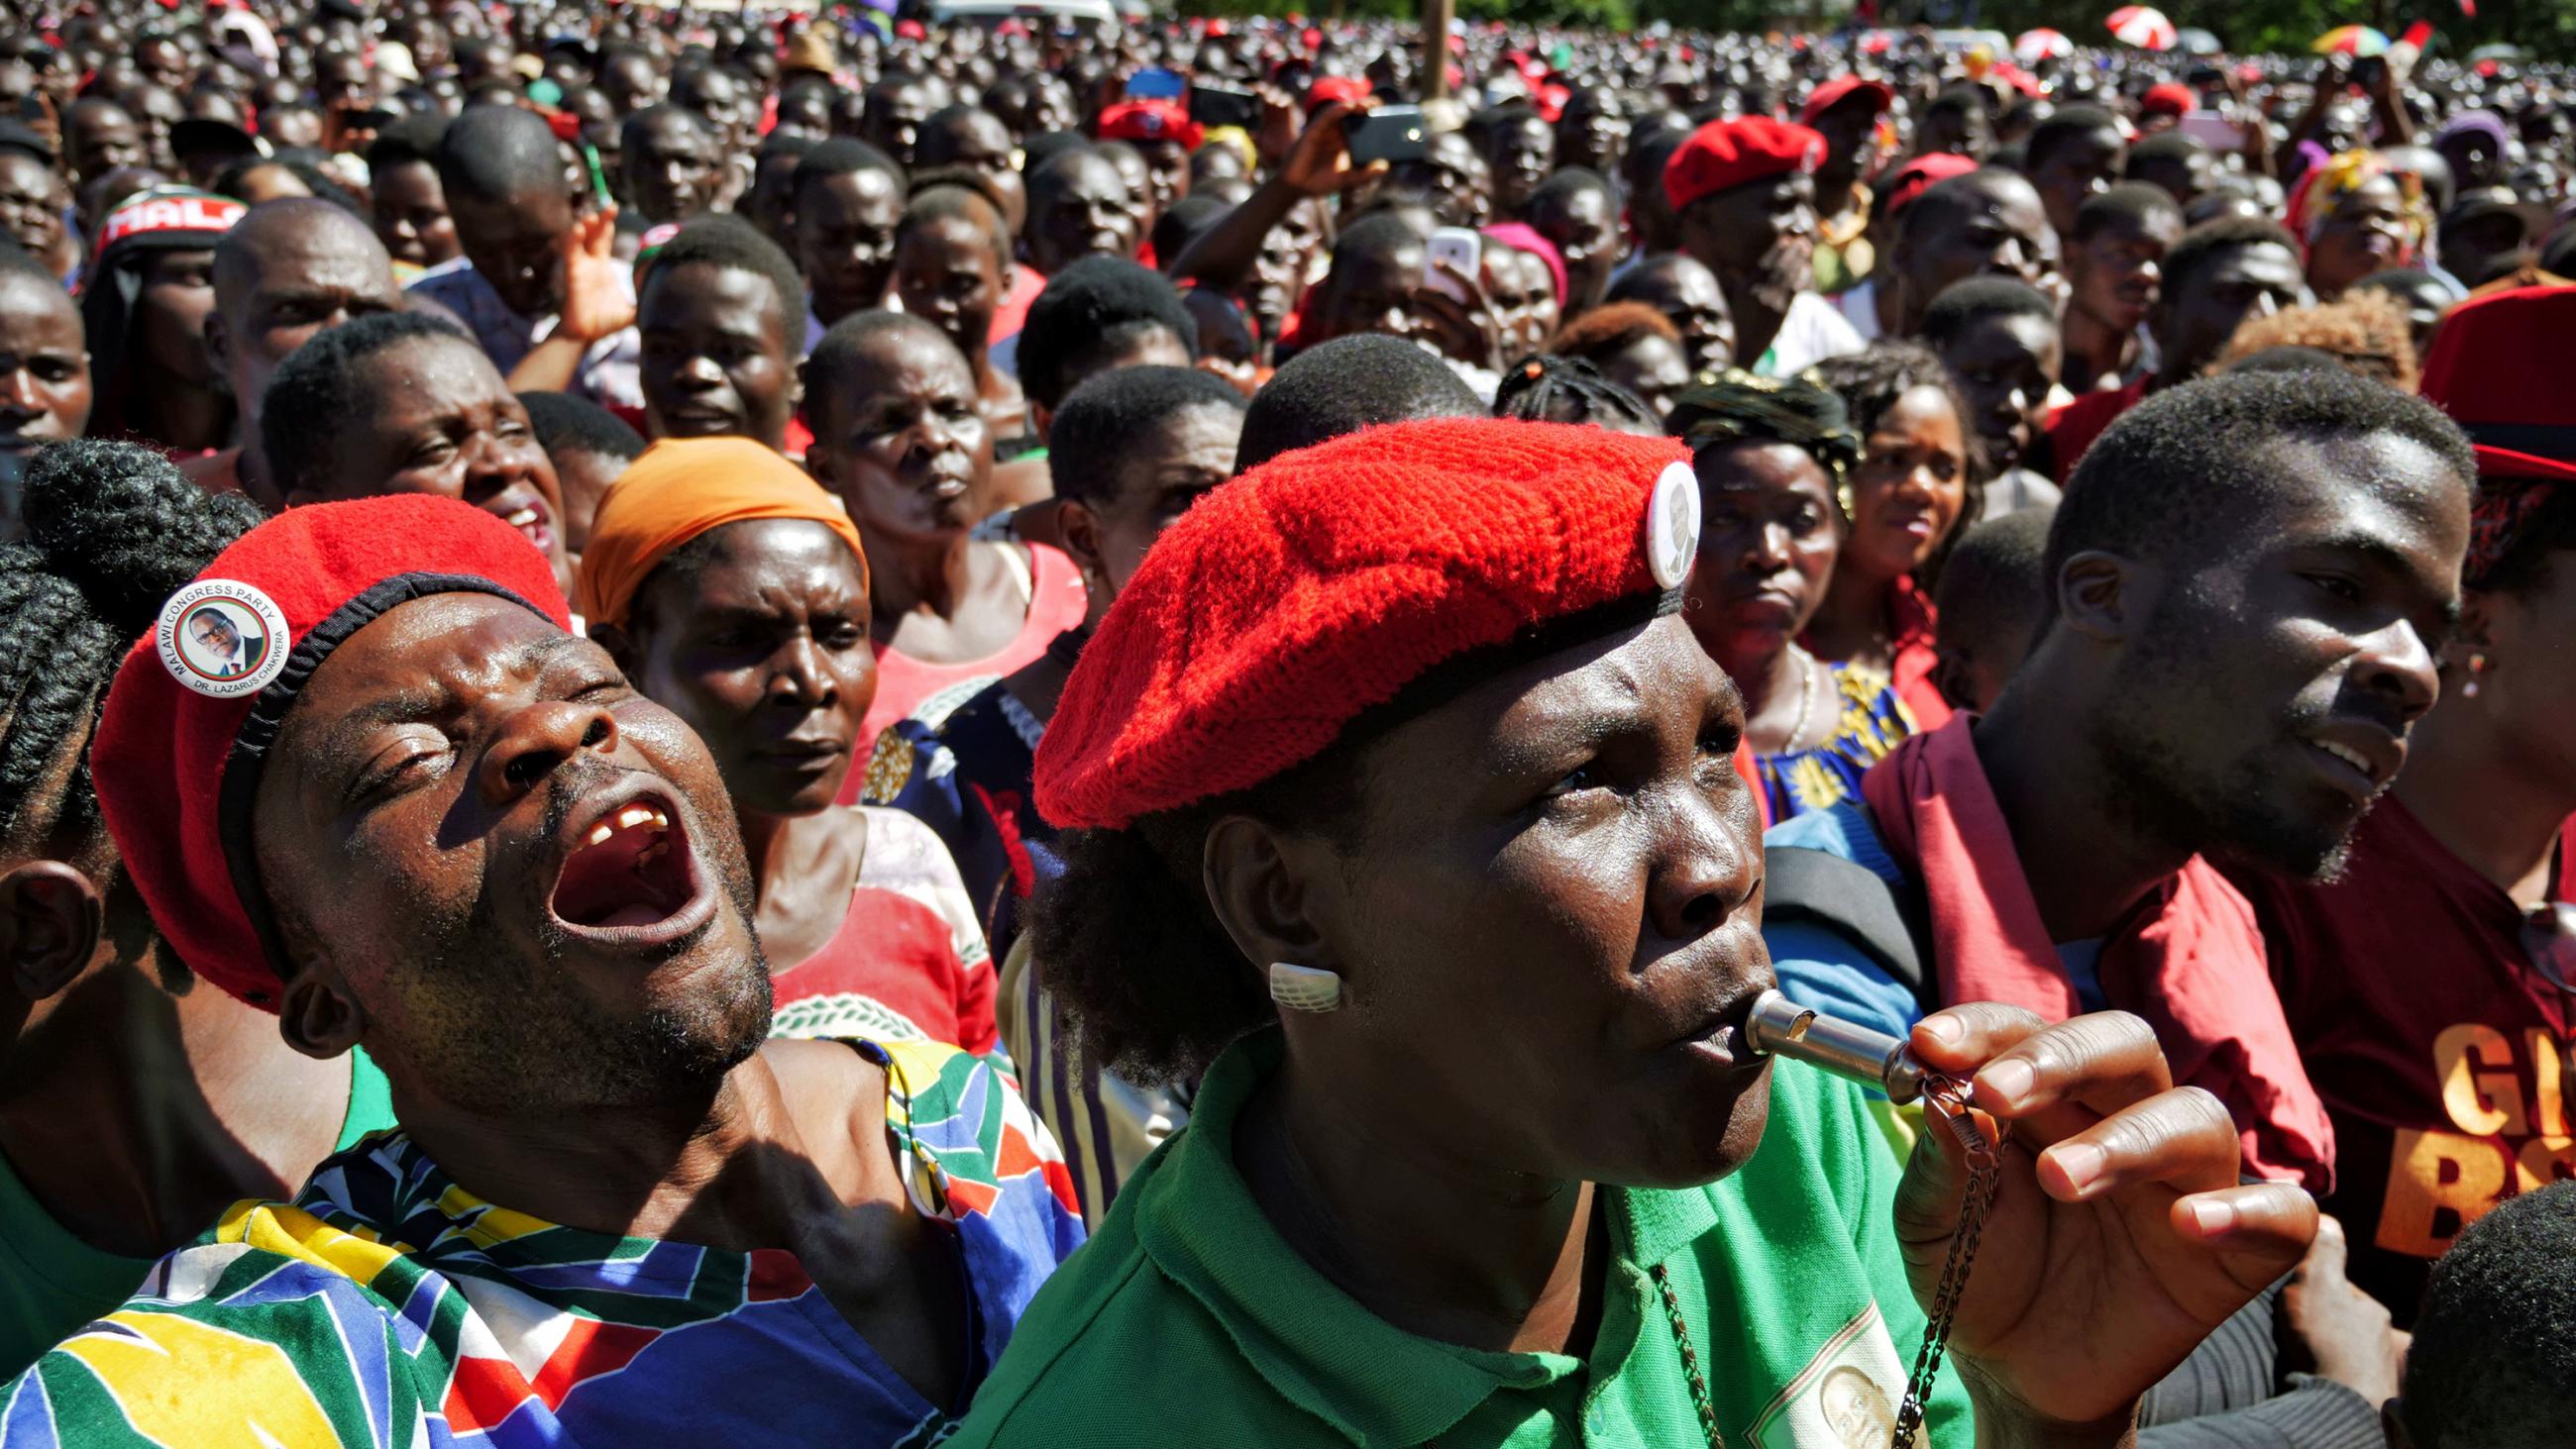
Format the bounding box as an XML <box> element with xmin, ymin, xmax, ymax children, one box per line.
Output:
<box><xmin>770</xmin><ymin>885</ymin><xmax>1000</xmax><ymax>1055</ymax></box>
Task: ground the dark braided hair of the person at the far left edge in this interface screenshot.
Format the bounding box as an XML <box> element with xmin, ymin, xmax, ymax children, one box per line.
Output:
<box><xmin>0</xmin><ymin>438</ymin><xmax>261</xmax><ymax>860</ymax></box>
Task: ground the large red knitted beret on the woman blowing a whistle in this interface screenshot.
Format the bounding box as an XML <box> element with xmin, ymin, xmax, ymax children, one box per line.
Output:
<box><xmin>1035</xmin><ymin>417</ymin><xmax>1700</xmax><ymax>829</ymax></box>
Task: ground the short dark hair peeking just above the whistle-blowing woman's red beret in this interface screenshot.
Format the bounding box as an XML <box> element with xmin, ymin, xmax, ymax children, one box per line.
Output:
<box><xmin>1234</xmin><ymin>332</ymin><xmax>1486</xmax><ymax>473</ymax></box>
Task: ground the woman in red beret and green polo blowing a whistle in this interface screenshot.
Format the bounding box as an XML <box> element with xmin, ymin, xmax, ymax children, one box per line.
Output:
<box><xmin>950</xmin><ymin>420</ymin><xmax>2315</xmax><ymax>1449</ymax></box>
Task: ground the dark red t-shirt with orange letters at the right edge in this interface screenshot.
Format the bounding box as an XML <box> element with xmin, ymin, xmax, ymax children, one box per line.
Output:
<box><xmin>2236</xmin><ymin>800</ymin><xmax>2576</xmax><ymax>1325</ymax></box>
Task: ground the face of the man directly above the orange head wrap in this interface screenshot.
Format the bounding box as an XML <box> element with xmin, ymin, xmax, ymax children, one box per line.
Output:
<box><xmin>636</xmin><ymin>262</ymin><xmax>796</xmax><ymax>448</ymax></box>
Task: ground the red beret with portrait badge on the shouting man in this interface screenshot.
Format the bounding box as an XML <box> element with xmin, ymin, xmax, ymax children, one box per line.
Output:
<box><xmin>90</xmin><ymin>494</ymin><xmax>572</xmax><ymax>1011</ymax></box>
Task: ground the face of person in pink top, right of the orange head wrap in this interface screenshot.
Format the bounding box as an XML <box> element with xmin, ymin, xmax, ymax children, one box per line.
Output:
<box><xmin>806</xmin><ymin>332</ymin><xmax>992</xmax><ymax>538</ymax></box>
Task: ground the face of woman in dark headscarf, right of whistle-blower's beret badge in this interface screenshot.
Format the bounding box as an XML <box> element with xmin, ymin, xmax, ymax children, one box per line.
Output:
<box><xmin>1684</xmin><ymin>443</ymin><xmax>1842</xmax><ymax>676</ymax></box>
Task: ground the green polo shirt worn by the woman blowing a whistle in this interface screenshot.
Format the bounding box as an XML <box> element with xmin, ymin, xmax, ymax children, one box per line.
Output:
<box><xmin>945</xmin><ymin>1032</ymin><xmax>1974</xmax><ymax>1449</ymax></box>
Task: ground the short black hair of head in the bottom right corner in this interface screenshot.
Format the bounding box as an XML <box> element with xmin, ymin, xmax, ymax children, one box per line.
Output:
<box><xmin>2396</xmin><ymin>1182</ymin><xmax>2576</xmax><ymax>1449</ymax></box>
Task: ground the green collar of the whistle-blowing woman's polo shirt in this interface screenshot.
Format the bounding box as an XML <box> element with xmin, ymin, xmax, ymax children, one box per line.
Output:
<box><xmin>1130</xmin><ymin>1029</ymin><xmax>1716</xmax><ymax>1444</ymax></box>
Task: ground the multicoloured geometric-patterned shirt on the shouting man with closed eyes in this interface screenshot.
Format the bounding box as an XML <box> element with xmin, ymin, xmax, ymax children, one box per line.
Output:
<box><xmin>0</xmin><ymin>1042</ymin><xmax>1082</xmax><ymax>1449</ymax></box>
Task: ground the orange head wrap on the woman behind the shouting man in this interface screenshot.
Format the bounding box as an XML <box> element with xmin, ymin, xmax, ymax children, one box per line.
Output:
<box><xmin>572</xmin><ymin>438</ymin><xmax>868</xmax><ymax>628</ymax></box>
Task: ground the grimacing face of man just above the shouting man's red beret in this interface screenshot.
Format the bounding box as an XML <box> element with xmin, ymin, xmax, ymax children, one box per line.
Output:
<box><xmin>311</xmin><ymin>337</ymin><xmax>564</xmax><ymax>571</ymax></box>
